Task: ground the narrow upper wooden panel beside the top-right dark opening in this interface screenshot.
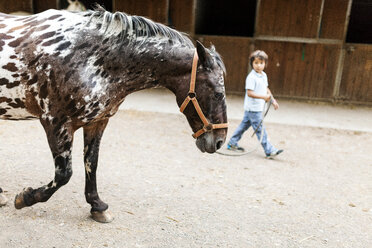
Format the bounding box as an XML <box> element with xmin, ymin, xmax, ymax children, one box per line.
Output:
<box><xmin>319</xmin><ymin>0</ymin><xmax>349</xmax><ymax>40</ymax></box>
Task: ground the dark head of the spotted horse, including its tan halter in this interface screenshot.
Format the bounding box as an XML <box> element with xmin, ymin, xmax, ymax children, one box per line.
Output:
<box><xmin>177</xmin><ymin>42</ymin><xmax>227</xmax><ymax>153</ymax></box>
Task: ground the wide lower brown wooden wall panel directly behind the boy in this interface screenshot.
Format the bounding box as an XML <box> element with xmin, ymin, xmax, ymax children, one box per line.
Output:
<box><xmin>196</xmin><ymin>36</ymin><xmax>341</xmax><ymax>100</ymax></box>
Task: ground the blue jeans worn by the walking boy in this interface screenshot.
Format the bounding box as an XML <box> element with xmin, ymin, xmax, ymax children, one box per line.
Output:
<box><xmin>229</xmin><ymin>111</ymin><xmax>277</xmax><ymax>155</ymax></box>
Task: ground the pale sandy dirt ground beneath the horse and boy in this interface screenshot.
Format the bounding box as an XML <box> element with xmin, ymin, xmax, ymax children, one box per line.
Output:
<box><xmin>0</xmin><ymin>110</ymin><xmax>372</xmax><ymax>248</ymax></box>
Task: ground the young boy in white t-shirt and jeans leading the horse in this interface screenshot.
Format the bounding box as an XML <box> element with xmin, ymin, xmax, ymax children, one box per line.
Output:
<box><xmin>227</xmin><ymin>50</ymin><xmax>283</xmax><ymax>158</ymax></box>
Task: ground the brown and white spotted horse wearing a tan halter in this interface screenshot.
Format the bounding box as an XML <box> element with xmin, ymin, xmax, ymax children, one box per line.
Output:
<box><xmin>0</xmin><ymin>8</ymin><xmax>227</xmax><ymax>222</ymax></box>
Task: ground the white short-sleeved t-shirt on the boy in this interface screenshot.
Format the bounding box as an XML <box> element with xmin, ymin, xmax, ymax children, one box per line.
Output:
<box><xmin>244</xmin><ymin>70</ymin><xmax>269</xmax><ymax>112</ymax></box>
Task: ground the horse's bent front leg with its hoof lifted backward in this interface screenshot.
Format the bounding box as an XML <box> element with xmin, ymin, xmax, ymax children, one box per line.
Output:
<box><xmin>14</xmin><ymin>120</ymin><xmax>74</xmax><ymax>209</ymax></box>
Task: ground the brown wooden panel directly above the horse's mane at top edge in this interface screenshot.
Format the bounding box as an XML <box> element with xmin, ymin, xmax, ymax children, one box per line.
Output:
<box><xmin>113</xmin><ymin>0</ymin><xmax>168</xmax><ymax>24</ymax></box>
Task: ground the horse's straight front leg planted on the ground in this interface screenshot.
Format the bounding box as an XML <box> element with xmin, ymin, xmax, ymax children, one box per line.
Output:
<box><xmin>84</xmin><ymin>119</ymin><xmax>113</xmax><ymax>223</ymax></box>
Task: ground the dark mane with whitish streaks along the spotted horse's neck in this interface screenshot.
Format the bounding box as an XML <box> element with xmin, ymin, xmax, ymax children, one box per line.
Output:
<box><xmin>86</xmin><ymin>5</ymin><xmax>194</xmax><ymax>48</ymax></box>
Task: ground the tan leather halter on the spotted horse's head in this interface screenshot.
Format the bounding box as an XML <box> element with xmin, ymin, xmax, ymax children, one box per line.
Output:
<box><xmin>180</xmin><ymin>50</ymin><xmax>229</xmax><ymax>139</ymax></box>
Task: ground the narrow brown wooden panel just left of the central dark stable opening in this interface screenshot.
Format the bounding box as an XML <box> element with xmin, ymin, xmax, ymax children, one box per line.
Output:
<box><xmin>169</xmin><ymin>0</ymin><xmax>195</xmax><ymax>34</ymax></box>
